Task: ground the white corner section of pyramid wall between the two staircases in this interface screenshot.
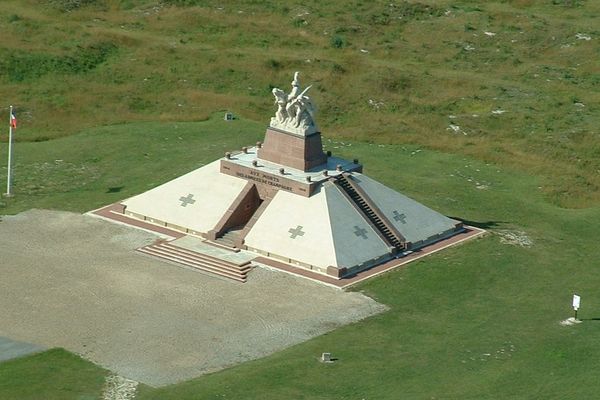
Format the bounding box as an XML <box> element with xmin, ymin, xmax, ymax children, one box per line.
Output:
<box><xmin>245</xmin><ymin>182</ymin><xmax>389</xmax><ymax>271</ymax></box>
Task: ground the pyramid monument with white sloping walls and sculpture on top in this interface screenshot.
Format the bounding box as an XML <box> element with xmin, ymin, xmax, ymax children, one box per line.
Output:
<box><xmin>122</xmin><ymin>72</ymin><xmax>464</xmax><ymax>279</ymax></box>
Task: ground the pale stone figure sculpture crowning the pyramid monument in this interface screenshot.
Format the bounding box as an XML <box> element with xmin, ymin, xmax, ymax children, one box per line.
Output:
<box><xmin>271</xmin><ymin>72</ymin><xmax>318</xmax><ymax>136</ymax></box>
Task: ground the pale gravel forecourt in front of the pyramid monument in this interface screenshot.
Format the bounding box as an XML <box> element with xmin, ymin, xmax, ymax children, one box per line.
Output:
<box><xmin>0</xmin><ymin>210</ymin><xmax>385</xmax><ymax>386</ymax></box>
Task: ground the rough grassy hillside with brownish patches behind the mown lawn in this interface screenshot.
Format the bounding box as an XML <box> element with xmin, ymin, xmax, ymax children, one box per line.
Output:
<box><xmin>0</xmin><ymin>0</ymin><xmax>600</xmax><ymax>207</ymax></box>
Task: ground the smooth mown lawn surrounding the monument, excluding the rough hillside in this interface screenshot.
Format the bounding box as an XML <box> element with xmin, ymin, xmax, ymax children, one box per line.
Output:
<box><xmin>0</xmin><ymin>115</ymin><xmax>600</xmax><ymax>399</ymax></box>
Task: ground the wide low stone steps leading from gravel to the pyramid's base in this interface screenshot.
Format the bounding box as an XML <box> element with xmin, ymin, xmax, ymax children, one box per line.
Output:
<box><xmin>137</xmin><ymin>241</ymin><xmax>252</xmax><ymax>283</ymax></box>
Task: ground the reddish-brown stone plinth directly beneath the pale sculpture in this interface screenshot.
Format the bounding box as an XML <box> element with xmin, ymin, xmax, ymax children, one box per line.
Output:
<box><xmin>258</xmin><ymin>127</ymin><xmax>327</xmax><ymax>171</ymax></box>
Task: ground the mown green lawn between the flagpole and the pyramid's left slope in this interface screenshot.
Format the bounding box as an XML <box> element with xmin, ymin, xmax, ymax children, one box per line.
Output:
<box><xmin>0</xmin><ymin>114</ymin><xmax>264</xmax><ymax>214</ymax></box>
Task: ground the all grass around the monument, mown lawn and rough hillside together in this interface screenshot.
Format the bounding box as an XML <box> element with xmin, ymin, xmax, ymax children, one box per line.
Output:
<box><xmin>0</xmin><ymin>0</ymin><xmax>600</xmax><ymax>399</ymax></box>
